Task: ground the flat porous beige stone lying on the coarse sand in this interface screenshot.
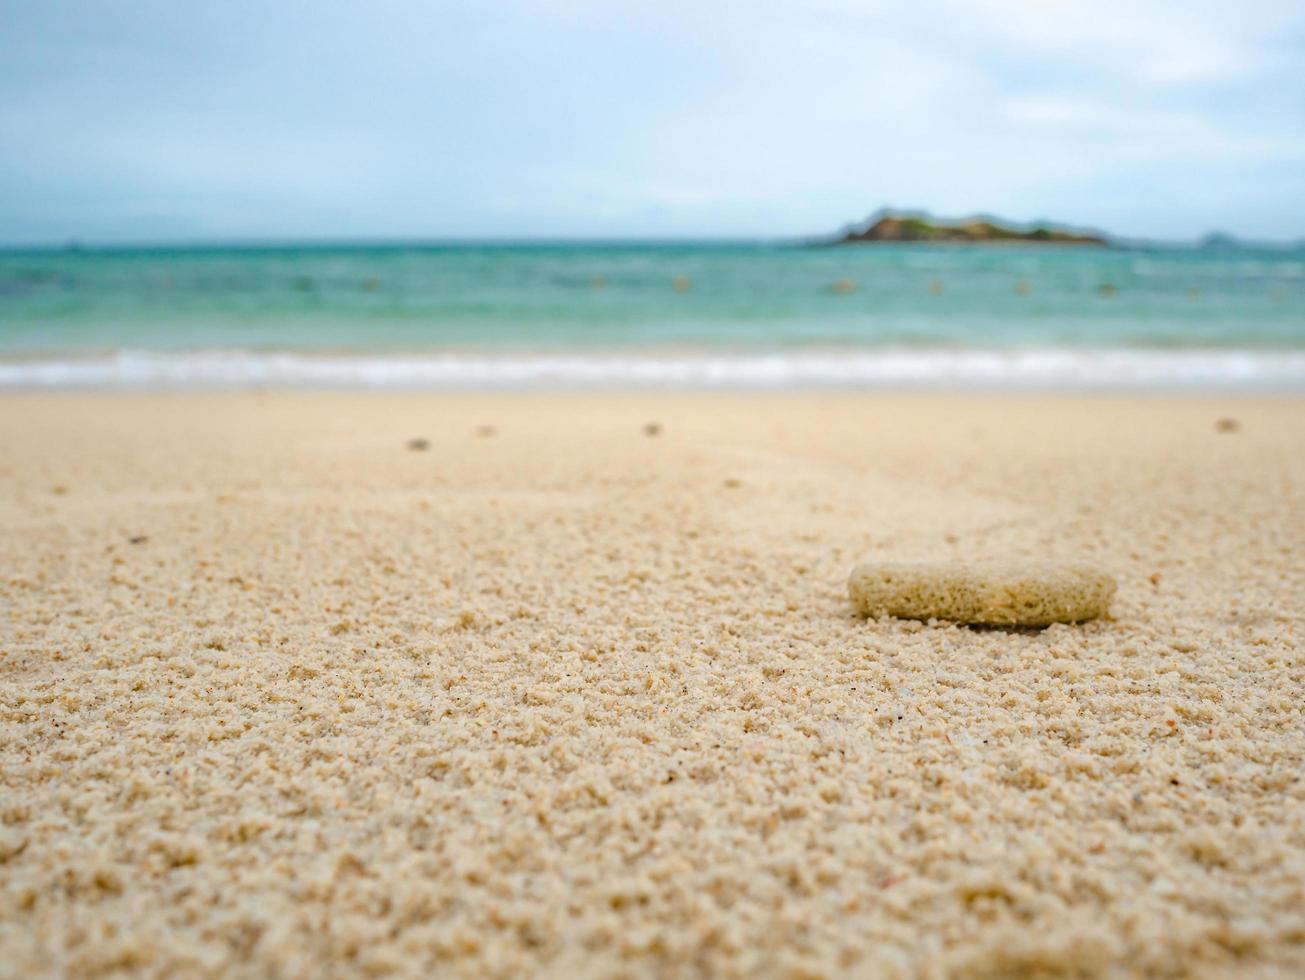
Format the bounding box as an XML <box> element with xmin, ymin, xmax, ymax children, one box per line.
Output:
<box><xmin>847</xmin><ymin>561</ymin><xmax>1116</xmax><ymax>626</ymax></box>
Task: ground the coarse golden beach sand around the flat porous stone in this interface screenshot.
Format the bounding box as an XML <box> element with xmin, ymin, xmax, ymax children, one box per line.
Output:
<box><xmin>0</xmin><ymin>394</ymin><xmax>1305</xmax><ymax>977</ymax></box>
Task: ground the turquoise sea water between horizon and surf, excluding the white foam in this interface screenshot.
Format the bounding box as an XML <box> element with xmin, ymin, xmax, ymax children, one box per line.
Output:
<box><xmin>0</xmin><ymin>244</ymin><xmax>1305</xmax><ymax>384</ymax></box>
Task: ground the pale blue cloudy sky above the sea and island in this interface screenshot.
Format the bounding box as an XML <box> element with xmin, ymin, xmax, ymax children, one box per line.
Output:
<box><xmin>0</xmin><ymin>0</ymin><xmax>1305</xmax><ymax>244</ymax></box>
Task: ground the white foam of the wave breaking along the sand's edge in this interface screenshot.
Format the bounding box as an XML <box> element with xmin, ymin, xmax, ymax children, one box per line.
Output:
<box><xmin>0</xmin><ymin>348</ymin><xmax>1305</xmax><ymax>390</ymax></box>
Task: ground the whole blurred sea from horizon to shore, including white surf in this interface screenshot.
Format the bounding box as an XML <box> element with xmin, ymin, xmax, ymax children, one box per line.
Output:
<box><xmin>0</xmin><ymin>243</ymin><xmax>1305</xmax><ymax>390</ymax></box>
